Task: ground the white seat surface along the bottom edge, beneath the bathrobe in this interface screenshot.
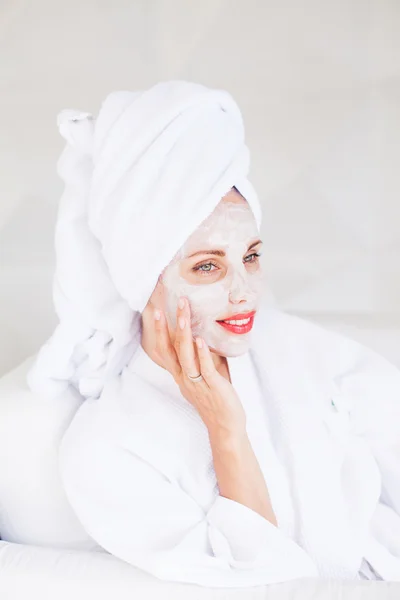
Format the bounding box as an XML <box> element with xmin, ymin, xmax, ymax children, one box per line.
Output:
<box><xmin>0</xmin><ymin>541</ymin><xmax>400</xmax><ymax>600</ymax></box>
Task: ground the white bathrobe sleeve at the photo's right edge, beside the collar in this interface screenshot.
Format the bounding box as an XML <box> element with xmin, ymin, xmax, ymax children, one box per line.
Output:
<box><xmin>340</xmin><ymin>345</ymin><xmax>400</xmax><ymax>581</ymax></box>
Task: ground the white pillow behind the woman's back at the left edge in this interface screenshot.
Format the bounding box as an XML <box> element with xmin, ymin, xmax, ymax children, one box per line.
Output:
<box><xmin>0</xmin><ymin>356</ymin><xmax>99</xmax><ymax>550</ymax></box>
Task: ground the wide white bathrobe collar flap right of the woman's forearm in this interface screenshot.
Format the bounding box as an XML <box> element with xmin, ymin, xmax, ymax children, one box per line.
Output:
<box><xmin>250</xmin><ymin>308</ymin><xmax>362</xmax><ymax>578</ymax></box>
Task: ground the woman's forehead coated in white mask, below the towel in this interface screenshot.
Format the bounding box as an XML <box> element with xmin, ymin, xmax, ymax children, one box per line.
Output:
<box><xmin>183</xmin><ymin>200</ymin><xmax>258</xmax><ymax>254</ymax></box>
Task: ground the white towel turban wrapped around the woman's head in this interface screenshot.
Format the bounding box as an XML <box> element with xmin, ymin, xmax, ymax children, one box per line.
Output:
<box><xmin>28</xmin><ymin>81</ymin><xmax>261</xmax><ymax>398</ymax></box>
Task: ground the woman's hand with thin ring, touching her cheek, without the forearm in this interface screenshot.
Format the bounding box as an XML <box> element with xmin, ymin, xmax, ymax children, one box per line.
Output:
<box><xmin>149</xmin><ymin>298</ymin><xmax>246</xmax><ymax>436</ymax></box>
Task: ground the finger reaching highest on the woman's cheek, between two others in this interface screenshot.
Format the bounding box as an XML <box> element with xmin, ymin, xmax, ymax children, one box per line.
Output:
<box><xmin>175</xmin><ymin>298</ymin><xmax>200</xmax><ymax>376</ymax></box>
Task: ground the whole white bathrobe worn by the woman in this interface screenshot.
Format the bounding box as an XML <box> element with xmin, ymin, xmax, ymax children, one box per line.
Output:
<box><xmin>60</xmin><ymin>307</ymin><xmax>400</xmax><ymax>587</ymax></box>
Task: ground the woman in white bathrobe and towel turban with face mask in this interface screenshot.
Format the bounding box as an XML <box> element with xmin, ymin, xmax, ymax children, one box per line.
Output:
<box><xmin>26</xmin><ymin>82</ymin><xmax>400</xmax><ymax>587</ymax></box>
